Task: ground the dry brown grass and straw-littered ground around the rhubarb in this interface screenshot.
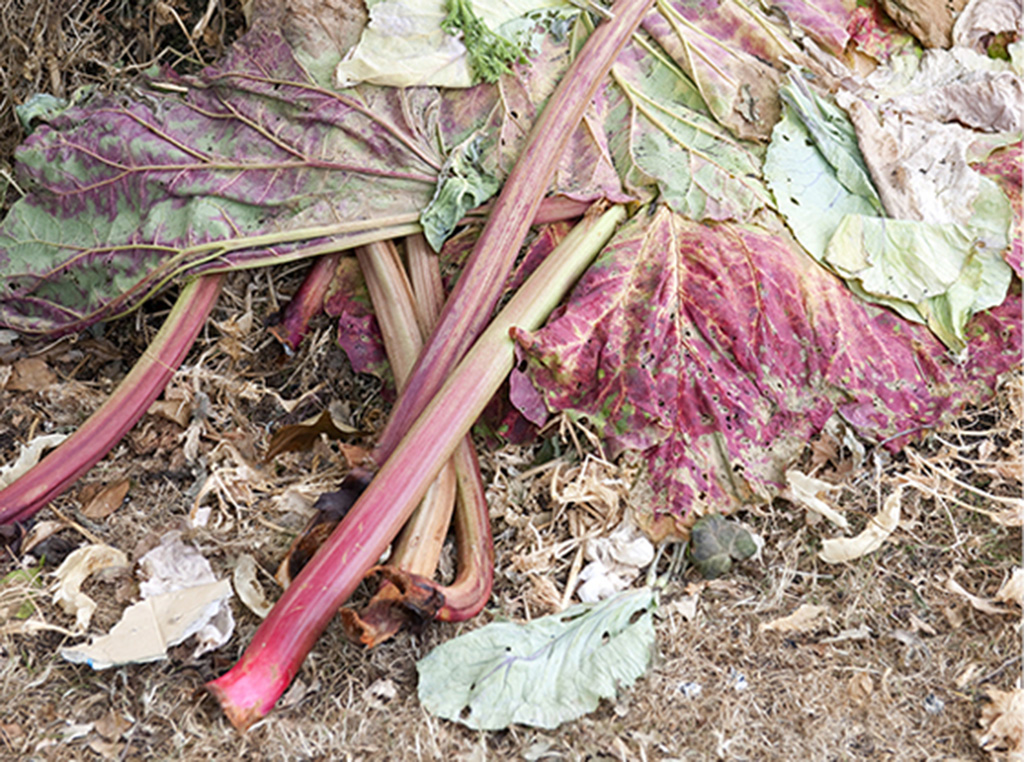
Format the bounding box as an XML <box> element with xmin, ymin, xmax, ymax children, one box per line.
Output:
<box><xmin>0</xmin><ymin>0</ymin><xmax>1022</xmax><ymax>760</ymax></box>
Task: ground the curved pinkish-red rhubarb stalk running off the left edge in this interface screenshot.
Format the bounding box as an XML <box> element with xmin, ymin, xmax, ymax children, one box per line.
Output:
<box><xmin>0</xmin><ymin>274</ymin><xmax>224</xmax><ymax>524</ymax></box>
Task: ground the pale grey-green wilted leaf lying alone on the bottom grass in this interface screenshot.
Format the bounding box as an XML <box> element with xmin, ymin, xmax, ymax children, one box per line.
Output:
<box><xmin>416</xmin><ymin>588</ymin><xmax>655</xmax><ymax>730</ymax></box>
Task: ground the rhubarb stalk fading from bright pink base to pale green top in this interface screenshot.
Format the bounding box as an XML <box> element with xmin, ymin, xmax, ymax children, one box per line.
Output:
<box><xmin>208</xmin><ymin>206</ymin><xmax>626</xmax><ymax>729</ymax></box>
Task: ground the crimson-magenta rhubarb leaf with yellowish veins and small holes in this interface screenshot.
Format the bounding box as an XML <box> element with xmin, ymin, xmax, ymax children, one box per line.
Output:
<box><xmin>516</xmin><ymin>207</ymin><xmax>1021</xmax><ymax>519</ymax></box>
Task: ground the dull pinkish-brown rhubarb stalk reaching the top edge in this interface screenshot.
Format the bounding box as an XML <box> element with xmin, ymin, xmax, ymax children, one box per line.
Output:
<box><xmin>375</xmin><ymin>0</ymin><xmax>653</xmax><ymax>462</ymax></box>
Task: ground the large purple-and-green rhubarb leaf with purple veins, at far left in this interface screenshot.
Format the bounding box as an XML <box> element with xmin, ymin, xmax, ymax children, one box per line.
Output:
<box><xmin>0</xmin><ymin>13</ymin><xmax>627</xmax><ymax>334</ymax></box>
